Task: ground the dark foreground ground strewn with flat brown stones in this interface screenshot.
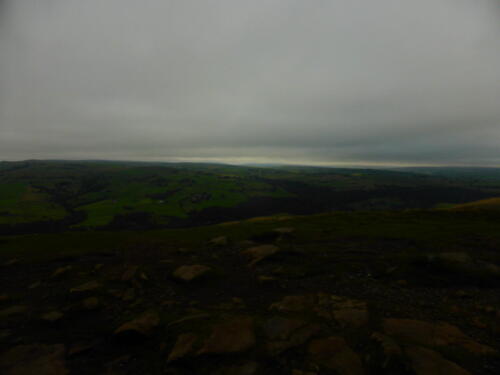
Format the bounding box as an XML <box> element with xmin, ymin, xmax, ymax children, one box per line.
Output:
<box><xmin>0</xmin><ymin>214</ymin><xmax>500</xmax><ymax>375</ymax></box>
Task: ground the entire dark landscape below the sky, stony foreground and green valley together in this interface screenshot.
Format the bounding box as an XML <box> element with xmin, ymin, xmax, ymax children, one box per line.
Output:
<box><xmin>0</xmin><ymin>161</ymin><xmax>500</xmax><ymax>375</ymax></box>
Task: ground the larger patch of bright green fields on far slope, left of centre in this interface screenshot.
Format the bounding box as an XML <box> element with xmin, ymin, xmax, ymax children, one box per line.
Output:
<box><xmin>77</xmin><ymin>171</ymin><xmax>290</xmax><ymax>226</ymax></box>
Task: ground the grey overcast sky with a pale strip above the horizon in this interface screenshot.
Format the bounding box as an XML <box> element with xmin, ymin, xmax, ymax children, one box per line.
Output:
<box><xmin>0</xmin><ymin>0</ymin><xmax>500</xmax><ymax>166</ymax></box>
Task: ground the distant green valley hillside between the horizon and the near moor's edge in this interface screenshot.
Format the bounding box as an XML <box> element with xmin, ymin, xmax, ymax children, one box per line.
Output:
<box><xmin>0</xmin><ymin>160</ymin><xmax>500</xmax><ymax>233</ymax></box>
